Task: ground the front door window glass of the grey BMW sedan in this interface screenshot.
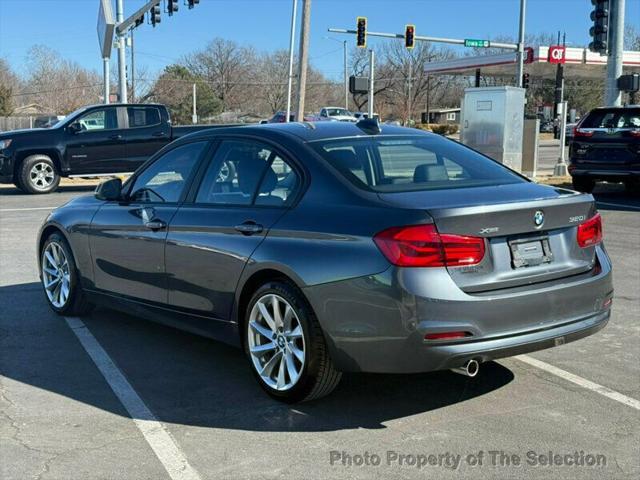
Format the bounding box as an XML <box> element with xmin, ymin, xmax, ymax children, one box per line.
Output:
<box><xmin>129</xmin><ymin>142</ymin><xmax>207</xmax><ymax>203</ymax></box>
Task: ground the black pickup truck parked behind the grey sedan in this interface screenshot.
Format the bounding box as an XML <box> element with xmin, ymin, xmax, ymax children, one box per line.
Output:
<box><xmin>0</xmin><ymin>104</ymin><xmax>225</xmax><ymax>193</ymax></box>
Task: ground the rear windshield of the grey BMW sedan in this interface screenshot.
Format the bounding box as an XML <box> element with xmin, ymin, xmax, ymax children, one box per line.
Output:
<box><xmin>311</xmin><ymin>135</ymin><xmax>526</xmax><ymax>192</ymax></box>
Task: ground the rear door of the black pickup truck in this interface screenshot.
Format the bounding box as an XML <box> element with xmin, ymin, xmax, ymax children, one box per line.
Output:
<box><xmin>122</xmin><ymin>105</ymin><xmax>171</xmax><ymax>172</ymax></box>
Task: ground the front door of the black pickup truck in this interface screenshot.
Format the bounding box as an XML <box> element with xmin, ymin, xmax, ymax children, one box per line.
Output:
<box><xmin>65</xmin><ymin>106</ymin><xmax>125</xmax><ymax>175</ymax></box>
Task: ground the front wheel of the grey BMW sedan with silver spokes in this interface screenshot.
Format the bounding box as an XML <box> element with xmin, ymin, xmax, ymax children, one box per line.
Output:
<box><xmin>40</xmin><ymin>233</ymin><xmax>93</xmax><ymax>316</ymax></box>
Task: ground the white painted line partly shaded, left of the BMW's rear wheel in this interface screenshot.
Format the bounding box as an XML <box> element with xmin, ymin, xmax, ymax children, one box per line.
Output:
<box><xmin>65</xmin><ymin>317</ymin><xmax>201</xmax><ymax>480</ymax></box>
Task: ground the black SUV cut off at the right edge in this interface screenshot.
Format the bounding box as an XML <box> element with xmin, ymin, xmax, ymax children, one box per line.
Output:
<box><xmin>569</xmin><ymin>106</ymin><xmax>640</xmax><ymax>192</ymax></box>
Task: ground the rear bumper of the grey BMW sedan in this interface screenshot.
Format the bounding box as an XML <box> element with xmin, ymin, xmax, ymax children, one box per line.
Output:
<box><xmin>305</xmin><ymin>247</ymin><xmax>613</xmax><ymax>373</ymax></box>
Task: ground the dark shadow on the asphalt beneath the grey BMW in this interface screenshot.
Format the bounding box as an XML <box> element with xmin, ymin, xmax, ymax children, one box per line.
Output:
<box><xmin>0</xmin><ymin>283</ymin><xmax>514</xmax><ymax>432</ymax></box>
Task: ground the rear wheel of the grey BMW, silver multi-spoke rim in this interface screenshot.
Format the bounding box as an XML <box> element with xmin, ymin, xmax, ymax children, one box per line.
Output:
<box><xmin>243</xmin><ymin>281</ymin><xmax>342</xmax><ymax>403</ymax></box>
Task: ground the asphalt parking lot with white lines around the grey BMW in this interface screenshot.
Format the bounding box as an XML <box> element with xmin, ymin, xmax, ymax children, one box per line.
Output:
<box><xmin>0</xmin><ymin>185</ymin><xmax>640</xmax><ymax>480</ymax></box>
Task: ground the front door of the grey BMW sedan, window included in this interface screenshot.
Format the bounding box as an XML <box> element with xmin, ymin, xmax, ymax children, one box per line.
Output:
<box><xmin>90</xmin><ymin>141</ymin><xmax>209</xmax><ymax>304</ymax></box>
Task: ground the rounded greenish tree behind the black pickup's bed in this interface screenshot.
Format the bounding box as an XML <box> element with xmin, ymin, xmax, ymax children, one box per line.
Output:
<box><xmin>147</xmin><ymin>65</ymin><xmax>222</xmax><ymax>125</ymax></box>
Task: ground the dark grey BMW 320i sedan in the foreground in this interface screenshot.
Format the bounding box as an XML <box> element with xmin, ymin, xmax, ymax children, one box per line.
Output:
<box><xmin>37</xmin><ymin>120</ymin><xmax>613</xmax><ymax>402</ymax></box>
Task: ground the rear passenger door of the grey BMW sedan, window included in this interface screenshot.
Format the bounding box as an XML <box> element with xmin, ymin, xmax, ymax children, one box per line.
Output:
<box><xmin>166</xmin><ymin>139</ymin><xmax>301</xmax><ymax>320</ymax></box>
